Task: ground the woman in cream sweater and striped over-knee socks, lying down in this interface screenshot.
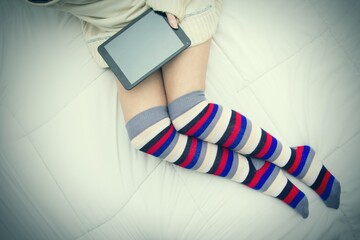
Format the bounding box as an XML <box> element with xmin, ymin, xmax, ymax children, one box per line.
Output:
<box><xmin>28</xmin><ymin>0</ymin><xmax>341</xmax><ymax>218</ymax></box>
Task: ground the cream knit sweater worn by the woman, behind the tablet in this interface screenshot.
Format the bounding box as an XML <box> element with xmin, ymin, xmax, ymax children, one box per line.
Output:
<box><xmin>25</xmin><ymin>0</ymin><xmax>222</xmax><ymax>68</ymax></box>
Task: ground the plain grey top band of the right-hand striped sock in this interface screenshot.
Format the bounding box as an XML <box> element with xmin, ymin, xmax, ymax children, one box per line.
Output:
<box><xmin>168</xmin><ymin>91</ymin><xmax>206</xmax><ymax>119</ymax></box>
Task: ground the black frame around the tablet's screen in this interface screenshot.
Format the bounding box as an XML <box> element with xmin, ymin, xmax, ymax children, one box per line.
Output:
<box><xmin>98</xmin><ymin>8</ymin><xmax>191</xmax><ymax>90</ymax></box>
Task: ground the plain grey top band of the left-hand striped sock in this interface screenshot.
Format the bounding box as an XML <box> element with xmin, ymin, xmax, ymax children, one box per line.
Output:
<box><xmin>126</xmin><ymin>106</ymin><xmax>169</xmax><ymax>140</ymax></box>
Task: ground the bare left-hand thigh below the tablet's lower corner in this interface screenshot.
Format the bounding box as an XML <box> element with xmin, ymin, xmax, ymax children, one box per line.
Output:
<box><xmin>114</xmin><ymin>71</ymin><xmax>167</xmax><ymax>122</ymax></box>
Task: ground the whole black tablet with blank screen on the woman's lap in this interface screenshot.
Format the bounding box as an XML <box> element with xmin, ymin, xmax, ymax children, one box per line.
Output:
<box><xmin>98</xmin><ymin>9</ymin><xmax>191</xmax><ymax>90</ymax></box>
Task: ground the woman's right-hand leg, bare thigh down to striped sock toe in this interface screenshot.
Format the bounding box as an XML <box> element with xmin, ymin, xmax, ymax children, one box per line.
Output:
<box><xmin>163</xmin><ymin>42</ymin><xmax>340</xmax><ymax>208</ymax></box>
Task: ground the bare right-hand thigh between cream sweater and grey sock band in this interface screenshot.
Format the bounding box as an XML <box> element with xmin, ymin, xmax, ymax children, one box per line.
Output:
<box><xmin>162</xmin><ymin>40</ymin><xmax>211</xmax><ymax>103</ymax></box>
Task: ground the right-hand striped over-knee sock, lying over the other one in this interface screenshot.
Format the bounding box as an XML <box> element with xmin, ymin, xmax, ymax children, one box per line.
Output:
<box><xmin>168</xmin><ymin>91</ymin><xmax>341</xmax><ymax>208</ymax></box>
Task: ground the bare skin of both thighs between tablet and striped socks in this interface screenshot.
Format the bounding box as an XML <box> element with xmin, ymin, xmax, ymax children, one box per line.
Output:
<box><xmin>114</xmin><ymin>40</ymin><xmax>211</xmax><ymax>122</ymax></box>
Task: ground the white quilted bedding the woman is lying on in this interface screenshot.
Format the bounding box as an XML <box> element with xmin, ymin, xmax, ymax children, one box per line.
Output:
<box><xmin>0</xmin><ymin>0</ymin><xmax>360</xmax><ymax>240</ymax></box>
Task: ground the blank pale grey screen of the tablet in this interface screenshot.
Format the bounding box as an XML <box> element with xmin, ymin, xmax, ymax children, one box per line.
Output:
<box><xmin>104</xmin><ymin>12</ymin><xmax>184</xmax><ymax>84</ymax></box>
